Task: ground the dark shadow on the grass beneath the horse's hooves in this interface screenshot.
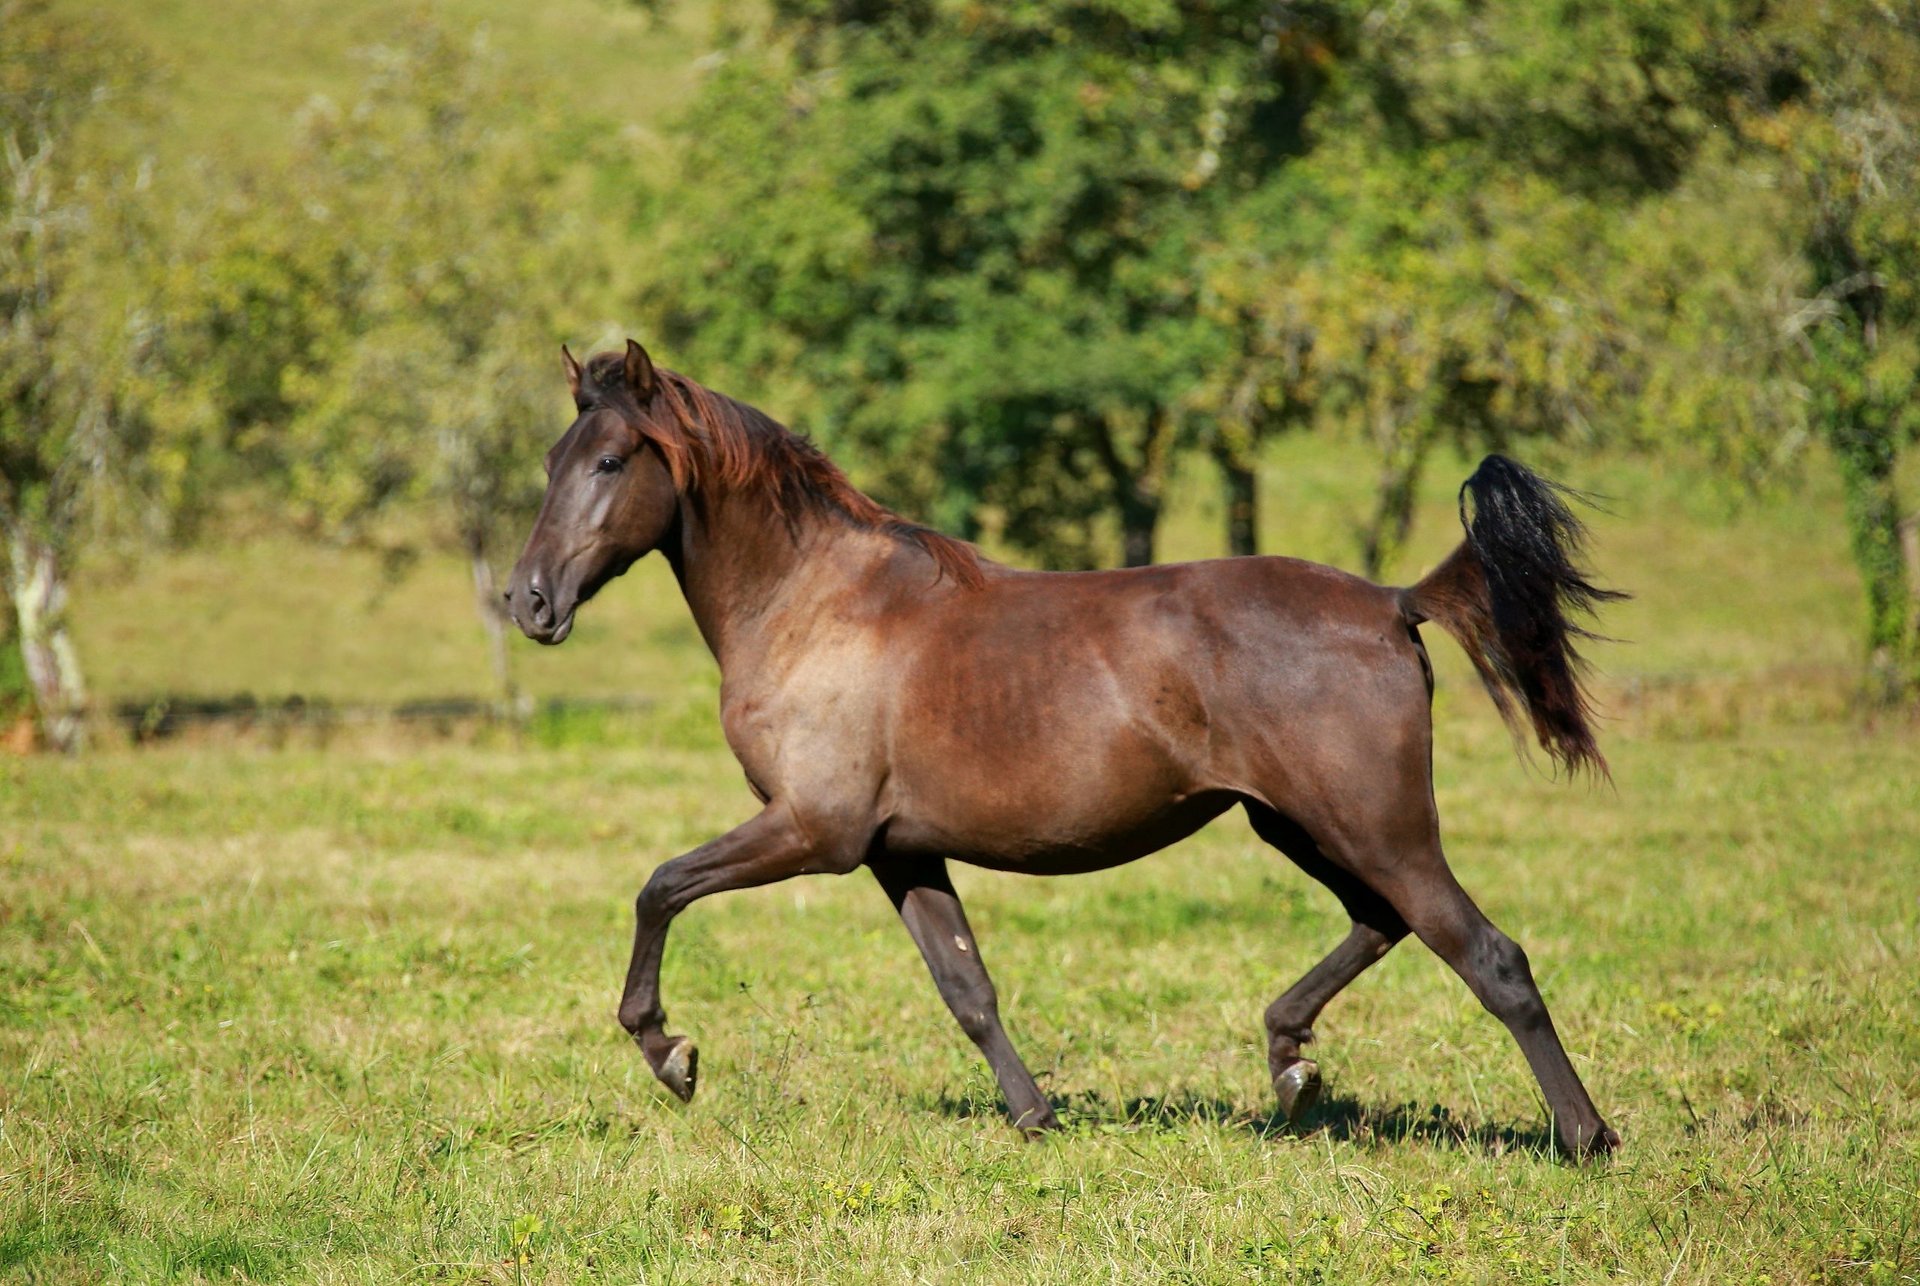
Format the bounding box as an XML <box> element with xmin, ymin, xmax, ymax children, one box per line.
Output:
<box><xmin>933</xmin><ymin>1090</ymin><xmax>1557</xmax><ymax>1159</ymax></box>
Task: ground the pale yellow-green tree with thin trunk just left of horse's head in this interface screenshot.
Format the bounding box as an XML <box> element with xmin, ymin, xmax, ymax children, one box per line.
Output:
<box><xmin>173</xmin><ymin>21</ymin><xmax>611</xmax><ymax>708</ymax></box>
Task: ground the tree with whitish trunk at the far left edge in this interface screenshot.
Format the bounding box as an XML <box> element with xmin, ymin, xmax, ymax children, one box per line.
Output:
<box><xmin>0</xmin><ymin>0</ymin><xmax>156</xmax><ymax>750</ymax></box>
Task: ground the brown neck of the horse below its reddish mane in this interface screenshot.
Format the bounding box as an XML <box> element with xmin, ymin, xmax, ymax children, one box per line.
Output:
<box><xmin>666</xmin><ymin>495</ymin><xmax>870</xmax><ymax>672</ymax></box>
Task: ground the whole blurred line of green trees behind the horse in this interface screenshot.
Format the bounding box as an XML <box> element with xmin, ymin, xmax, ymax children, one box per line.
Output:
<box><xmin>0</xmin><ymin>0</ymin><xmax>1920</xmax><ymax>745</ymax></box>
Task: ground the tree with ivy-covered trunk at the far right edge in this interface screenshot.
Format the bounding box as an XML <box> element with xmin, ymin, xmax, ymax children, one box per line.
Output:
<box><xmin>1622</xmin><ymin>0</ymin><xmax>1920</xmax><ymax>701</ymax></box>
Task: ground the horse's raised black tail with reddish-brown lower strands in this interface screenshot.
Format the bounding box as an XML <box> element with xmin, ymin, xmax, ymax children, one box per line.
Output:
<box><xmin>1402</xmin><ymin>455</ymin><xmax>1626</xmax><ymax>775</ymax></box>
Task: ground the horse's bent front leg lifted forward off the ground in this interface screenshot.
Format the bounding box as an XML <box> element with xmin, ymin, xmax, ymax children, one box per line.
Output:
<box><xmin>620</xmin><ymin>800</ymin><xmax>864</xmax><ymax>1102</ymax></box>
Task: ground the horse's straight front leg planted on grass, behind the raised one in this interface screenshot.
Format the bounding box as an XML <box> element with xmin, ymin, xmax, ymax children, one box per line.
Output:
<box><xmin>870</xmin><ymin>858</ymin><xmax>1060</xmax><ymax>1136</ymax></box>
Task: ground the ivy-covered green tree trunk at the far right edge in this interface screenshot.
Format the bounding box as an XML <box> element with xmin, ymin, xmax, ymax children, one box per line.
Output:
<box><xmin>1828</xmin><ymin>417</ymin><xmax>1920</xmax><ymax>704</ymax></box>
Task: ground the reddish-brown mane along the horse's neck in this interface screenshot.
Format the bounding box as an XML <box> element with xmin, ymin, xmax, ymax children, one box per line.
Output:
<box><xmin>586</xmin><ymin>353</ymin><xmax>985</xmax><ymax>589</ymax></box>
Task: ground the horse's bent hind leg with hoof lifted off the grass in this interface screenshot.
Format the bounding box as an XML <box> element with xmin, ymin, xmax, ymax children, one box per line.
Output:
<box><xmin>1246</xmin><ymin>800</ymin><xmax>1407</xmax><ymax>1123</ymax></box>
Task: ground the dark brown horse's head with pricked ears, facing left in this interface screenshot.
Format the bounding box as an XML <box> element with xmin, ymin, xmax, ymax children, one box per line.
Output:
<box><xmin>507</xmin><ymin>340</ymin><xmax>680</xmax><ymax>643</ymax></box>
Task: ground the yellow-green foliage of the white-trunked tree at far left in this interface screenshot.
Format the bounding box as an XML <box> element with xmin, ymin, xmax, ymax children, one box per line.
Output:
<box><xmin>0</xmin><ymin>0</ymin><xmax>192</xmax><ymax>541</ymax></box>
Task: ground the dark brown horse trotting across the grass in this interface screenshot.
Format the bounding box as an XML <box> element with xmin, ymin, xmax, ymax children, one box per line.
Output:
<box><xmin>507</xmin><ymin>340</ymin><xmax>1619</xmax><ymax>1155</ymax></box>
